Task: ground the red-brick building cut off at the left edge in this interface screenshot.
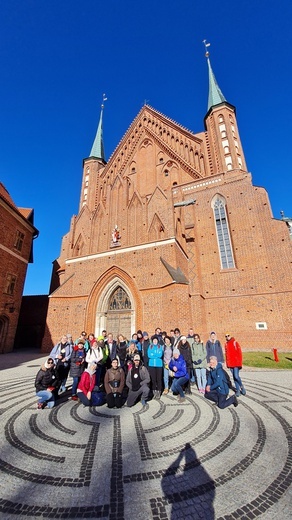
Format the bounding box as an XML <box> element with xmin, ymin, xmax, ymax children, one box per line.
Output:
<box><xmin>0</xmin><ymin>183</ymin><xmax>38</xmax><ymax>353</ymax></box>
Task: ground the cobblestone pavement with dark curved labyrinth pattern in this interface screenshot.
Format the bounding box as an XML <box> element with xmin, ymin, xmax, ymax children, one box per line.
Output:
<box><xmin>0</xmin><ymin>352</ymin><xmax>292</xmax><ymax>520</ymax></box>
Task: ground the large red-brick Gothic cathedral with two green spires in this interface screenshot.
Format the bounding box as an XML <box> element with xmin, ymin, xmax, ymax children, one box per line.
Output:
<box><xmin>43</xmin><ymin>53</ymin><xmax>292</xmax><ymax>351</ymax></box>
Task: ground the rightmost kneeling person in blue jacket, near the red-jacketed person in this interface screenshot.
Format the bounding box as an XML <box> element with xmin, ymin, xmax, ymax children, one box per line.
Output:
<box><xmin>205</xmin><ymin>356</ymin><xmax>238</xmax><ymax>408</ymax></box>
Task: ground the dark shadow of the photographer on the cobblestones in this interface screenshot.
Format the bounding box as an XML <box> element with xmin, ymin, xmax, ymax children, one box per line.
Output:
<box><xmin>161</xmin><ymin>443</ymin><xmax>215</xmax><ymax>520</ymax></box>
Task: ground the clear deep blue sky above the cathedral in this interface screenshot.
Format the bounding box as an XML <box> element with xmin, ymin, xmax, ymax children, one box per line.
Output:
<box><xmin>0</xmin><ymin>0</ymin><xmax>292</xmax><ymax>294</ymax></box>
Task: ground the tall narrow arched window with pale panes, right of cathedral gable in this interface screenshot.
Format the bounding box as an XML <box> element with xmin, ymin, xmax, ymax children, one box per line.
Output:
<box><xmin>212</xmin><ymin>196</ymin><xmax>235</xmax><ymax>269</ymax></box>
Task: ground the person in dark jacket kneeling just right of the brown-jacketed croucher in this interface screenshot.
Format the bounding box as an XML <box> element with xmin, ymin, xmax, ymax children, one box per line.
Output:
<box><xmin>126</xmin><ymin>354</ymin><xmax>150</xmax><ymax>406</ymax></box>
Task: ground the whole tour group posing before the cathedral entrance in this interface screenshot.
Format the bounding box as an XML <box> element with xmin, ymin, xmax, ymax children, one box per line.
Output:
<box><xmin>35</xmin><ymin>327</ymin><xmax>246</xmax><ymax>409</ymax></box>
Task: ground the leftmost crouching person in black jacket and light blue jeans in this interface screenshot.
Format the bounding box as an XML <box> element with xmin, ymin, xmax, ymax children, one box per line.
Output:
<box><xmin>35</xmin><ymin>358</ymin><xmax>58</xmax><ymax>410</ymax></box>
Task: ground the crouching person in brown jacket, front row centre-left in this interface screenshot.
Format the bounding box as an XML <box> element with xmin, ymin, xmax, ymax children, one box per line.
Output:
<box><xmin>104</xmin><ymin>358</ymin><xmax>125</xmax><ymax>408</ymax></box>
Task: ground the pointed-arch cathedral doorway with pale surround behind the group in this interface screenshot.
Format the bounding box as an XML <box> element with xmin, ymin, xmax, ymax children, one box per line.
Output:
<box><xmin>95</xmin><ymin>279</ymin><xmax>135</xmax><ymax>339</ymax></box>
